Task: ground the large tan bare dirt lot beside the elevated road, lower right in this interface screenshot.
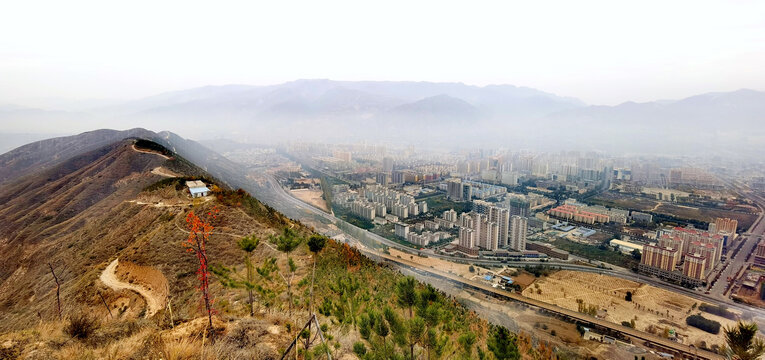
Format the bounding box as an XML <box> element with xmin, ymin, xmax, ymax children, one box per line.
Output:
<box><xmin>523</xmin><ymin>271</ymin><xmax>735</xmax><ymax>346</ymax></box>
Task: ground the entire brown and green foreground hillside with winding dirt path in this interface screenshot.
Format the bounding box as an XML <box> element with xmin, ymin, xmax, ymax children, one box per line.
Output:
<box><xmin>0</xmin><ymin>135</ymin><xmax>536</xmax><ymax>359</ymax></box>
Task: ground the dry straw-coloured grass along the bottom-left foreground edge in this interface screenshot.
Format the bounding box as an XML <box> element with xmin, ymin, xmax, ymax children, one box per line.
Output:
<box><xmin>0</xmin><ymin>313</ymin><xmax>290</xmax><ymax>360</ymax></box>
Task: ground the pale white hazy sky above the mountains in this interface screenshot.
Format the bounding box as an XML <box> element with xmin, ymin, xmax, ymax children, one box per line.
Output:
<box><xmin>0</xmin><ymin>0</ymin><xmax>765</xmax><ymax>104</ymax></box>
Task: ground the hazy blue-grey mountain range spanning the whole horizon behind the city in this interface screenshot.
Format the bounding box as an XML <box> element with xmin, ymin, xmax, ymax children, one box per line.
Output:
<box><xmin>0</xmin><ymin>80</ymin><xmax>765</xmax><ymax>151</ymax></box>
